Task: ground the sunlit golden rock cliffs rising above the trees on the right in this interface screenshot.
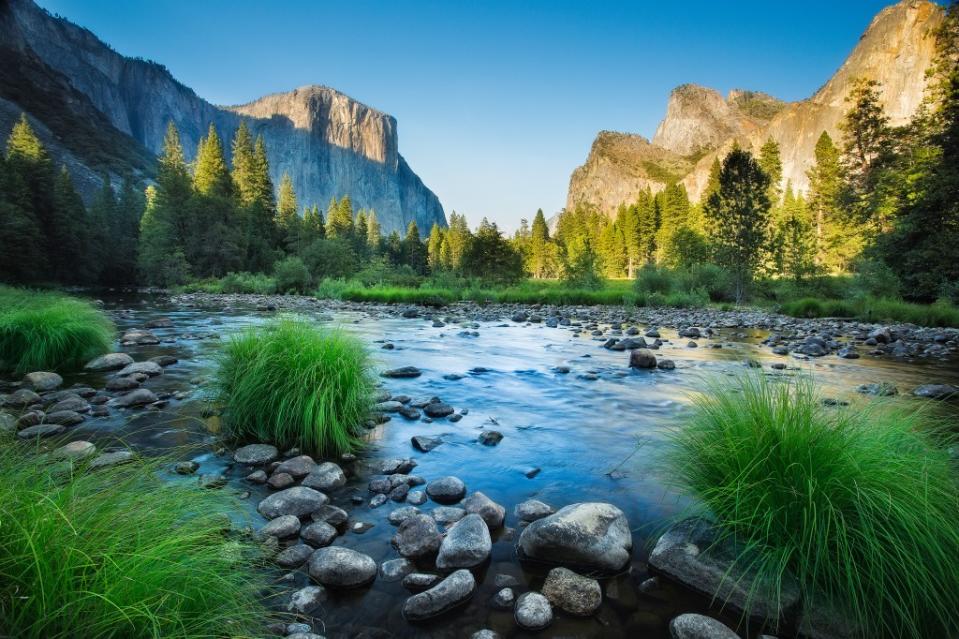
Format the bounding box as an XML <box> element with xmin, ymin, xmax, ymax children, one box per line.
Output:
<box><xmin>566</xmin><ymin>0</ymin><xmax>943</xmax><ymax>215</ymax></box>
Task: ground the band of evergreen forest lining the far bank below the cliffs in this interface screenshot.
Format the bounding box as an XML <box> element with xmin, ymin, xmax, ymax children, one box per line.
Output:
<box><xmin>0</xmin><ymin>5</ymin><xmax>959</xmax><ymax>301</ymax></box>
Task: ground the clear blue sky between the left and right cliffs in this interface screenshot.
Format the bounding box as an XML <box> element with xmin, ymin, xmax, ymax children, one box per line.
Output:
<box><xmin>39</xmin><ymin>0</ymin><xmax>890</xmax><ymax>230</ymax></box>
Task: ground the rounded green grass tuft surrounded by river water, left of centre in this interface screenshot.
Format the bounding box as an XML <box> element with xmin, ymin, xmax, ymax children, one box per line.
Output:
<box><xmin>217</xmin><ymin>317</ymin><xmax>373</xmax><ymax>456</ymax></box>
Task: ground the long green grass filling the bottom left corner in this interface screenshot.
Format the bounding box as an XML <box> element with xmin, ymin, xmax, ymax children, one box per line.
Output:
<box><xmin>0</xmin><ymin>441</ymin><xmax>268</xmax><ymax>639</ymax></box>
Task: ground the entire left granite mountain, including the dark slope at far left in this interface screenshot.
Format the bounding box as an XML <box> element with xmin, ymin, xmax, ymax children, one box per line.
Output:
<box><xmin>0</xmin><ymin>0</ymin><xmax>446</xmax><ymax>233</ymax></box>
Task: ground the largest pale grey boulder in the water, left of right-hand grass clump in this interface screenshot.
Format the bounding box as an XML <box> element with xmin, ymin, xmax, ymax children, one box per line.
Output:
<box><xmin>519</xmin><ymin>502</ymin><xmax>633</xmax><ymax>572</ymax></box>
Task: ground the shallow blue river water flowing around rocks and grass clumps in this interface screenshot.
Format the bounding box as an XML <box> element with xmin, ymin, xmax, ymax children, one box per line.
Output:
<box><xmin>43</xmin><ymin>296</ymin><xmax>959</xmax><ymax>638</ymax></box>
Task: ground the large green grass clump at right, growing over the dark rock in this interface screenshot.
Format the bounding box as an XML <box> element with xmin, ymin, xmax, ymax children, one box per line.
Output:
<box><xmin>667</xmin><ymin>376</ymin><xmax>959</xmax><ymax>637</ymax></box>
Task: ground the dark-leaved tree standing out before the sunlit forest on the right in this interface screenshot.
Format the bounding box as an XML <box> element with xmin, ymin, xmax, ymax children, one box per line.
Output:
<box><xmin>705</xmin><ymin>148</ymin><xmax>770</xmax><ymax>303</ymax></box>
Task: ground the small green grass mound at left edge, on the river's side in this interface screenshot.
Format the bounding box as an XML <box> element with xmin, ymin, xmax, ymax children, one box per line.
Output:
<box><xmin>0</xmin><ymin>287</ymin><xmax>114</xmax><ymax>374</ymax></box>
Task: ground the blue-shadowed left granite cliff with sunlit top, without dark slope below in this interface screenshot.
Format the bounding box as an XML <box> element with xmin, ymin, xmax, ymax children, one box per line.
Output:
<box><xmin>0</xmin><ymin>0</ymin><xmax>446</xmax><ymax>233</ymax></box>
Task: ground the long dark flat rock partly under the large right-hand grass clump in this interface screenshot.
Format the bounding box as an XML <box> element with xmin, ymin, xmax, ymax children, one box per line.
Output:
<box><xmin>649</xmin><ymin>518</ymin><xmax>800</xmax><ymax>623</ymax></box>
